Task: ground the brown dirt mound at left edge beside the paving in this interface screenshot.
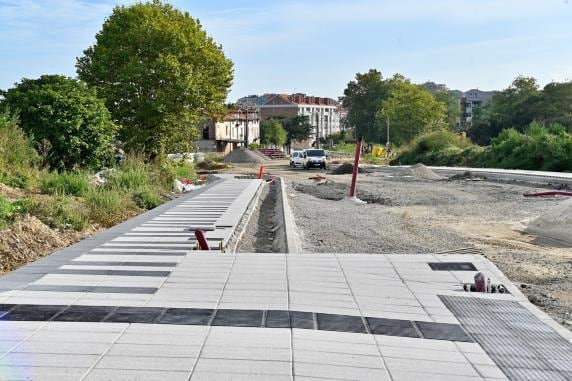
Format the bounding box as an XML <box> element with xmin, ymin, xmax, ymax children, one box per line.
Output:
<box><xmin>0</xmin><ymin>216</ymin><xmax>93</xmax><ymax>274</ymax></box>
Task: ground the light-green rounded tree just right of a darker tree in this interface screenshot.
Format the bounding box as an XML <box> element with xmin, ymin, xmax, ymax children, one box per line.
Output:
<box><xmin>377</xmin><ymin>78</ymin><xmax>447</xmax><ymax>144</ymax></box>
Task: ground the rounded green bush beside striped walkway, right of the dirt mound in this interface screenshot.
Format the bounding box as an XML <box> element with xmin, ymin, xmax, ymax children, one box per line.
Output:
<box><xmin>85</xmin><ymin>189</ymin><xmax>137</xmax><ymax>227</ymax></box>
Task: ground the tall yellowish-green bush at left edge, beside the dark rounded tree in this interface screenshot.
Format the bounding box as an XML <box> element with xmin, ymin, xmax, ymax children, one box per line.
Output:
<box><xmin>0</xmin><ymin>111</ymin><xmax>40</xmax><ymax>189</ymax></box>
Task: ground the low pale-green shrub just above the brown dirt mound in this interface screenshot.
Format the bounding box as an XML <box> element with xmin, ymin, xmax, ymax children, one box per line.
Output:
<box><xmin>32</xmin><ymin>193</ymin><xmax>88</xmax><ymax>231</ymax></box>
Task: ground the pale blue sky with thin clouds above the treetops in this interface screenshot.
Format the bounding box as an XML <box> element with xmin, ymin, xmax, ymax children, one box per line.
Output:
<box><xmin>0</xmin><ymin>0</ymin><xmax>572</xmax><ymax>101</ymax></box>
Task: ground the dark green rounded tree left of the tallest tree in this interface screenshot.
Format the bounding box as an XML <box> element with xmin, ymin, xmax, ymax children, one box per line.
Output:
<box><xmin>1</xmin><ymin>75</ymin><xmax>117</xmax><ymax>170</ymax></box>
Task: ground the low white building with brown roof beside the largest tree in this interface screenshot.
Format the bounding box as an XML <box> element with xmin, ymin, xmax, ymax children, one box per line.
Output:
<box><xmin>196</xmin><ymin>110</ymin><xmax>260</xmax><ymax>154</ymax></box>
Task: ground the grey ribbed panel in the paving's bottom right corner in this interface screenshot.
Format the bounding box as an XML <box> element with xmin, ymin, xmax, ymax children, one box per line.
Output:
<box><xmin>439</xmin><ymin>296</ymin><xmax>572</xmax><ymax>381</ymax></box>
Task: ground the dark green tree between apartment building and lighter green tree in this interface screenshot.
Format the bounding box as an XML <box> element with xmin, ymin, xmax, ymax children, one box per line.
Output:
<box><xmin>340</xmin><ymin>69</ymin><xmax>388</xmax><ymax>142</ymax></box>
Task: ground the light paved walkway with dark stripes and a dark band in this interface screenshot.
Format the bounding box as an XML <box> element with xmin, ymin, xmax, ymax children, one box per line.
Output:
<box><xmin>0</xmin><ymin>176</ymin><xmax>572</xmax><ymax>381</ymax></box>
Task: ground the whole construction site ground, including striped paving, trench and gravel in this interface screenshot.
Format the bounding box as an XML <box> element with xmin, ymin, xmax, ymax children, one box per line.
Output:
<box><xmin>0</xmin><ymin>149</ymin><xmax>572</xmax><ymax>381</ymax></box>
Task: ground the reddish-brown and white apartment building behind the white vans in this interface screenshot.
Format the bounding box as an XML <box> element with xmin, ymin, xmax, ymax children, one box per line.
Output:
<box><xmin>255</xmin><ymin>93</ymin><xmax>340</xmax><ymax>145</ymax></box>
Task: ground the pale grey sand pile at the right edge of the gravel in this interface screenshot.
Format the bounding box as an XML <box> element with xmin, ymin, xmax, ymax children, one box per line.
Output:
<box><xmin>526</xmin><ymin>198</ymin><xmax>572</xmax><ymax>244</ymax></box>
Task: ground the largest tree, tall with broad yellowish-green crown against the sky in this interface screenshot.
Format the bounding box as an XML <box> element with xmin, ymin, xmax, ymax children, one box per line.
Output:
<box><xmin>76</xmin><ymin>0</ymin><xmax>233</xmax><ymax>157</ymax></box>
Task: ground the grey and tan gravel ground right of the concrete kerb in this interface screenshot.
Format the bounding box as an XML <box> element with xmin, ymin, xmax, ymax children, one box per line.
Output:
<box><xmin>260</xmin><ymin>165</ymin><xmax>572</xmax><ymax>328</ymax></box>
